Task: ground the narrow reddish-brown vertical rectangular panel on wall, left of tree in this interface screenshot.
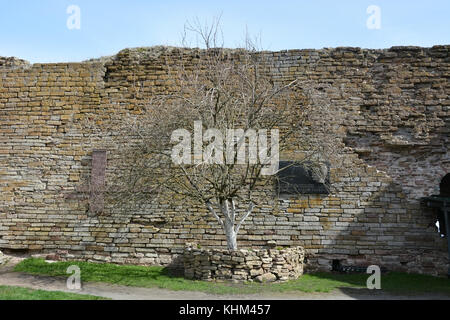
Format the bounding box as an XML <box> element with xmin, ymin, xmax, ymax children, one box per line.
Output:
<box><xmin>89</xmin><ymin>150</ymin><xmax>106</xmax><ymax>214</ymax></box>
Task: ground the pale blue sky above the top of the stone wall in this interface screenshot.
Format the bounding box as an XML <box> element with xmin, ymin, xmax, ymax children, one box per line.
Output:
<box><xmin>0</xmin><ymin>0</ymin><xmax>450</xmax><ymax>63</ymax></box>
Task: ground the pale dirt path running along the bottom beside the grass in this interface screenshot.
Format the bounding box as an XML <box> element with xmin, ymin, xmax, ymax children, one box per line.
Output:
<box><xmin>0</xmin><ymin>256</ymin><xmax>450</xmax><ymax>300</ymax></box>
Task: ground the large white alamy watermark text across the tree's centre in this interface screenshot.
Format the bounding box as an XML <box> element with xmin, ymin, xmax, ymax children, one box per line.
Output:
<box><xmin>171</xmin><ymin>121</ymin><xmax>279</xmax><ymax>175</ymax></box>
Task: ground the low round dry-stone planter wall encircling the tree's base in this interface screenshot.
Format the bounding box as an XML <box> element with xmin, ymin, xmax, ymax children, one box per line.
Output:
<box><xmin>183</xmin><ymin>244</ymin><xmax>305</xmax><ymax>282</ymax></box>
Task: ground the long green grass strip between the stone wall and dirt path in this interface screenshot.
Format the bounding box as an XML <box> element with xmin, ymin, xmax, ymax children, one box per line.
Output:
<box><xmin>14</xmin><ymin>258</ymin><xmax>450</xmax><ymax>295</ymax></box>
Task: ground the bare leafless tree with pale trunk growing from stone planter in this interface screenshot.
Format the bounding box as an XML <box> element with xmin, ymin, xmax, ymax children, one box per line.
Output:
<box><xmin>100</xmin><ymin>20</ymin><xmax>336</xmax><ymax>250</ymax></box>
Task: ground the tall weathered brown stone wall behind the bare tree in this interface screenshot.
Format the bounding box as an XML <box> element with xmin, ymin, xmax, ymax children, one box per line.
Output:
<box><xmin>0</xmin><ymin>46</ymin><xmax>450</xmax><ymax>274</ymax></box>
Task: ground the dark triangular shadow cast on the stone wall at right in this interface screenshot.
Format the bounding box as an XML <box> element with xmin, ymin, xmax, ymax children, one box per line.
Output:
<box><xmin>317</xmin><ymin>181</ymin><xmax>448</xmax><ymax>276</ymax></box>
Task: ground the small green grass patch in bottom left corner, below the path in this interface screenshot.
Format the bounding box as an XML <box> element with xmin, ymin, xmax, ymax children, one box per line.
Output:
<box><xmin>0</xmin><ymin>286</ymin><xmax>104</xmax><ymax>300</ymax></box>
